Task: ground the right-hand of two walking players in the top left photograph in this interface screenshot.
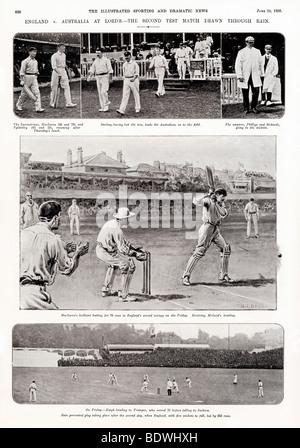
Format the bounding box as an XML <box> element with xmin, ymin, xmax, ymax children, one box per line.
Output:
<box><xmin>50</xmin><ymin>44</ymin><xmax>76</xmax><ymax>107</ymax></box>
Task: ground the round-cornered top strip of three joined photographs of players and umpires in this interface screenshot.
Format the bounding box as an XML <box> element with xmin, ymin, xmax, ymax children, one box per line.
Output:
<box><xmin>13</xmin><ymin>32</ymin><xmax>285</xmax><ymax>120</ymax></box>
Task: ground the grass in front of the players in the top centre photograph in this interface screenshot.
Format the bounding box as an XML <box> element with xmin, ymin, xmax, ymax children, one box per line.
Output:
<box><xmin>82</xmin><ymin>81</ymin><xmax>221</xmax><ymax>119</ymax></box>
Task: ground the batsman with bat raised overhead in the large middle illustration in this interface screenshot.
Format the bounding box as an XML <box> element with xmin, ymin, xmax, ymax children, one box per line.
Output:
<box><xmin>182</xmin><ymin>167</ymin><xmax>232</xmax><ymax>286</ymax></box>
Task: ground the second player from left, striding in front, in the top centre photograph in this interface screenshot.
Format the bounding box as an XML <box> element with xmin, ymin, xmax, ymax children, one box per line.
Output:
<box><xmin>117</xmin><ymin>51</ymin><xmax>141</xmax><ymax>115</ymax></box>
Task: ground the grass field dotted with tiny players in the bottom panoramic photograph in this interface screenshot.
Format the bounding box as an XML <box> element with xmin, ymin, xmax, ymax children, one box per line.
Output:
<box><xmin>13</xmin><ymin>367</ymin><xmax>283</xmax><ymax>405</ymax></box>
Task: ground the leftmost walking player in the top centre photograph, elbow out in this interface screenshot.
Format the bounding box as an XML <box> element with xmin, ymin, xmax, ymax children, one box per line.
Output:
<box><xmin>87</xmin><ymin>49</ymin><xmax>113</xmax><ymax>112</ymax></box>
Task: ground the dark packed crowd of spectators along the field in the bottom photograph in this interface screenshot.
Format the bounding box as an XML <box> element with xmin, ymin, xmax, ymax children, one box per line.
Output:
<box><xmin>58</xmin><ymin>348</ymin><xmax>283</xmax><ymax>369</ymax></box>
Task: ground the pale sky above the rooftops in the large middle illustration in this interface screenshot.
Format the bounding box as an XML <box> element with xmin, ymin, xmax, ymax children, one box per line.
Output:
<box><xmin>21</xmin><ymin>136</ymin><xmax>276</xmax><ymax>177</ymax></box>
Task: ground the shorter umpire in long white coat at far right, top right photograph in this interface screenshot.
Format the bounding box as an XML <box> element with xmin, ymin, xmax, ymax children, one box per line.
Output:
<box><xmin>260</xmin><ymin>45</ymin><xmax>278</xmax><ymax>106</ymax></box>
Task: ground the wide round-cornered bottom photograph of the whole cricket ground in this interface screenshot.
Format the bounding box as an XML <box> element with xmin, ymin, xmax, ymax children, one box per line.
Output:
<box><xmin>12</xmin><ymin>323</ymin><xmax>284</xmax><ymax>405</ymax></box>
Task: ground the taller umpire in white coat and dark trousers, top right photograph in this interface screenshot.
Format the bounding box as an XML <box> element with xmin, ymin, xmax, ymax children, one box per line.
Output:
<box><xmin>235</xmin><ymin>36</ymin><xmax>263</xmax><ymax>115</ymax></box>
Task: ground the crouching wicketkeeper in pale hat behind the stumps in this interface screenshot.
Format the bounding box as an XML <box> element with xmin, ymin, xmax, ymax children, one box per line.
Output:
<box><xmin>96</xmin><ymin>207</ymin><xmax>147</xmax><ymax>301</ymax></box>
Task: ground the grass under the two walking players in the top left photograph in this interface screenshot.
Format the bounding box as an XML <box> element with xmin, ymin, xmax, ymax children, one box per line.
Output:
<box><xmin>13</xmin><ymin>80</ymin><xmax>81</xmax><ymax>120</ymax></box>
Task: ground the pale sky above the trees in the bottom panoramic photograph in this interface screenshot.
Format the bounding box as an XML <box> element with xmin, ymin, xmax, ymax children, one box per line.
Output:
<box><xmin>134</xmin><ymin>324</ymin><xmax>280</xmax><ymax>339</ymax></box>
